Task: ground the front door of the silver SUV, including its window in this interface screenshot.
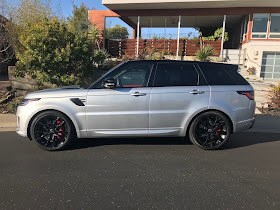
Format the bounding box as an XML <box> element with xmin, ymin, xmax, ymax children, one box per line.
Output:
<box><xmin>86</xmin><ymin>62</ymin><xmax>153</xmax><ymax>137</ymax></box>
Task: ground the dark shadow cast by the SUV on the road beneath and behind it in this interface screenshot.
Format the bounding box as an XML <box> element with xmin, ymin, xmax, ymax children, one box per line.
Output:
<box><xmin>67</xmin><ymin>132</ymin><xmax>280</xmax><ymax>150</ymax></box>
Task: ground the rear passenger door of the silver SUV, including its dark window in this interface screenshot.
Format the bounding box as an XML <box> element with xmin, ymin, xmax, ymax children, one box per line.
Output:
<box><xmin>149</xmin><ymin>62</ymin><xmax>210</xmax><ymax>136</ymax></box>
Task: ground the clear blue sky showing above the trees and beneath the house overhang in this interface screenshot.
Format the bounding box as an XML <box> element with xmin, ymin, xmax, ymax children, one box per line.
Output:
<box><xmin>12</xmin><ymin>0</ymin><xmax>198</xmax><ymax>38</ymax></box>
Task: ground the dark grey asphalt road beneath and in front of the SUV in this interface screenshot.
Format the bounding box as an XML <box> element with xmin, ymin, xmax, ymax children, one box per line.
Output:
<box><xmin>0</xmin><ymin>117</ymin><xmax>280</xmax><ymax>209</ymax></box>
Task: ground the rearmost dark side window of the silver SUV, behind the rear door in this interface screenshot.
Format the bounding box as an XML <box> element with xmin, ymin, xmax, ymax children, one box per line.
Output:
<box><xmin>198</xmin><ymin>63</ymin><xmax>249</xmax><ymax>85</ymax></box>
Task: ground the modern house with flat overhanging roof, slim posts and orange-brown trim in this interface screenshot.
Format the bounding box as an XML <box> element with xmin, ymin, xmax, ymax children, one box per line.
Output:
<box><xmin>89</xmin><ymin>0</ymin><xmax>280</xmax><ymax>79</ymax></box>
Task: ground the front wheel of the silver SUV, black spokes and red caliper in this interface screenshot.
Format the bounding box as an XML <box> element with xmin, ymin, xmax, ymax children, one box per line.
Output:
<box><xmin>30</xmin><ymin>111</ymin><xmax>76</xmax><ymax>151</ymax></box>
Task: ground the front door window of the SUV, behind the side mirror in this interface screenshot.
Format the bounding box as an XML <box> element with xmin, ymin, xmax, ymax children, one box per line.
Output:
<box><xmin>89</xmin><ymin>62</ymin><xmax>153</xmax><ymax>88</ymax></box>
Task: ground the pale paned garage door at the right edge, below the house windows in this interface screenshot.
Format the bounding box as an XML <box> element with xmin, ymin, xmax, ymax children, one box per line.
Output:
<box><xmin>261</xmin><ymin>52</ymin><xmax>280</xmax><ymax>79</ymax></box>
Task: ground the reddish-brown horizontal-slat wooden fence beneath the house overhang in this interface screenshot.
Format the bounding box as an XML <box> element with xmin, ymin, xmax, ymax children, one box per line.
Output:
<box><xmin>105</xmin><ymin>39</ymin><xmax>221</xmax><ymax>58</ymax></box>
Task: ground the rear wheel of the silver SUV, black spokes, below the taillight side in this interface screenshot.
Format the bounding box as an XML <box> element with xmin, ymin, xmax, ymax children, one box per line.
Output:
<box><xmin>189</xmin><ymin>111</ymin><xmax>232</xmax><ymax>150</ymax></box>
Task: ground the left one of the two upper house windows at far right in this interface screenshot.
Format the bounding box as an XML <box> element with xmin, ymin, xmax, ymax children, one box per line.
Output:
<box><xmin>252</xmin><ymin>14</ymin><xmax>269</xmax><ymax>39</ymax></box>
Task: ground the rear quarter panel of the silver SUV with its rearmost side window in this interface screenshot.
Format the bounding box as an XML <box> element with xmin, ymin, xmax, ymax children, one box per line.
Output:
<box><xmin>198</xmin><ymin>63</ymin><xmax>255</xmax><ymax>123</ymax></box>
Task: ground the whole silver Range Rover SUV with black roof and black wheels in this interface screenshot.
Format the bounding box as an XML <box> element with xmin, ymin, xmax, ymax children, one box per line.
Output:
<box><xmin>17</xmin><ymin>60</ymin><xmax>255</xmax><ymax>150</ymax></box>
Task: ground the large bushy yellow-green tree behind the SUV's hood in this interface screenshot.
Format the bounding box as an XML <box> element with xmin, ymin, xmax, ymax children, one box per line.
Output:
<box><xmin>15</xmin><ymin>17</ymin><xmax>106</xmax><ymax>86</ymax></box>
